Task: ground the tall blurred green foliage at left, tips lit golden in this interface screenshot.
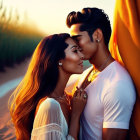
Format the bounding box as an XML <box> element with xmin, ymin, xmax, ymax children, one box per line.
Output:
<box><xmin>0</xmin><ymin>2</ymin><xmax>42</xmax><ymax>71</ymax></box>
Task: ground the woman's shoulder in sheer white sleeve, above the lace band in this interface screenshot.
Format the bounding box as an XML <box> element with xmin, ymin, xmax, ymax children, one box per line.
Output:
<box><xmin>33</xmin><ymin>98</ymin><xmax>63</xmax><ymax>132</ymax></box>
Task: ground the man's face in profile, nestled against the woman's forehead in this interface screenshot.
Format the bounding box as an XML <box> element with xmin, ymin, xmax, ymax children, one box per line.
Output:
<box><xmin>70</xmin><ymin>24</ymin><xmax>97</xmax><ymax>60</ymax></box>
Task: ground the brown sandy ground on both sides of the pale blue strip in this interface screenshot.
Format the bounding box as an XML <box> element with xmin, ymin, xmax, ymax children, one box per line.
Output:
<box><xmin>0</xmin><ymin>58</ymin><xmax>30</xmax><ymax>140</ymax></box>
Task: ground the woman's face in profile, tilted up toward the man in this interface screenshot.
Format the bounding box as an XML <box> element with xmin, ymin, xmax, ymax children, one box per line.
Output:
<box><xmin>61</xmin><ymin>38</ymin><xmax>83</xmax><ymax>74</ymax></box>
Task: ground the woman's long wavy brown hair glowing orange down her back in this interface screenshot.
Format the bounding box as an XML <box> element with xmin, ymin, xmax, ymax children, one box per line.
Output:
<box><xmin>9</xmin><ymin>34</ymin><xmax>70</xmax><ymax>140</ymax></box>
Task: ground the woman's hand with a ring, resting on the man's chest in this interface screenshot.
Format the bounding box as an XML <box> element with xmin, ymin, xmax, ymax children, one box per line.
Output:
<box><xmin>71</xmin><ymin>87</ymin><xmax>87</xmax><ymax>117</ymax></box>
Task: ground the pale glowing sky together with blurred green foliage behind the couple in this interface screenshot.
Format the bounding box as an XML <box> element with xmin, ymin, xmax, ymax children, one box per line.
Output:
<box><xmin>0</xmin><ymin>0</ymin><xmax>115</xmax><ymax>71</ymax></box>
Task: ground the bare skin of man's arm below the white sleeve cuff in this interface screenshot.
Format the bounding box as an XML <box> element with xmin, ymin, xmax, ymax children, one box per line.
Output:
<box><xmin>102</xmin><ymin>128</ymin><xmax>128</xmax><ymax>140</ymax></box>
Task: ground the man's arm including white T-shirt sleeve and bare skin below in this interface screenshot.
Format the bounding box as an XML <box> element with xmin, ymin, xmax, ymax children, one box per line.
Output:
<box><xmin>102</xmin><ymin>81</ymin><xmax>135</xmax><ymax>140</ymax></box>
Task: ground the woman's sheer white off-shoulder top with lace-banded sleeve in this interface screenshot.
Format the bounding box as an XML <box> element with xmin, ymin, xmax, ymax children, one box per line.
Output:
<box><xmin>31</xmin><ymin>98</ymin><xmax>74</xmax><ymax>140</ymax></box>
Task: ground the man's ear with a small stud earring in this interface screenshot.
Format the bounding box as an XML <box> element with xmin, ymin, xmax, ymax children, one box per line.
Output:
<box><xmin>92</xmin><ymin>28</ymin><xmax>103</xmax><ymax>43</ymax></box>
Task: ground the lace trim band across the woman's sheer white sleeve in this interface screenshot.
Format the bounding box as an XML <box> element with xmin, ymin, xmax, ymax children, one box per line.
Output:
<box><xmin>32</xmin><ymin>123</ymin><xmax>62</xmax><ymax>136</ymax></box>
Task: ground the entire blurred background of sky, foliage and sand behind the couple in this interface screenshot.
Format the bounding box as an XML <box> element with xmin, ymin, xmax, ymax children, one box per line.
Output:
<box><xmin>0</xmin><ymin>0</ymin><xmax>115</xmax><ymax>140</ymax></box>
